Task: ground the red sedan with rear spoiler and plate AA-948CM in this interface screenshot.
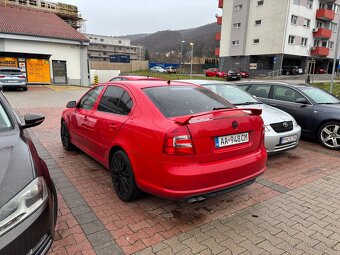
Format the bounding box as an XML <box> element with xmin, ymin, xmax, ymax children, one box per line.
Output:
<box><xmin>60</xmin><ymin>81</ymin><xmax>267</xmax><ymax>202</ymax></box>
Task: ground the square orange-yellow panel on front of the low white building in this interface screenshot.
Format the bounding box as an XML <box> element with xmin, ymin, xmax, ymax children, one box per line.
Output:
<box><xmin>26</xmin><ymin>58</ymin><xmax>51</xmax><ymax>83</ymax></box>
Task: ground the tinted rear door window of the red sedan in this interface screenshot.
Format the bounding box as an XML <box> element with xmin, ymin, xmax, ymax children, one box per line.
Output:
<box><xmin>98</xmin><ymin>86</ymin><xmax>132</xmax><ymax>115</ymax></box>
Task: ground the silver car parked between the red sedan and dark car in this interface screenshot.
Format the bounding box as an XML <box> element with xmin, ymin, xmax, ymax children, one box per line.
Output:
<box><xmin>178</xmin><ymin>80</ymin><xmax>301</xmax><ymax>153</ymax></box>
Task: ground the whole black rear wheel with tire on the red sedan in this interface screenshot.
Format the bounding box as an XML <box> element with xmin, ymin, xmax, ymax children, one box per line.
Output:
<box><xmin>110</xmin><ymin>150</ymin><xmax>141</xmax><ymax>202</ymax></box>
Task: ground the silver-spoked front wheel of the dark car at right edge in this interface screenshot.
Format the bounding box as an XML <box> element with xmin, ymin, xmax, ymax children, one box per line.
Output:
<box><xmin>318</xmin><ymin>121</ymin><xmax>340</xmax><ymax>150</ymax></box>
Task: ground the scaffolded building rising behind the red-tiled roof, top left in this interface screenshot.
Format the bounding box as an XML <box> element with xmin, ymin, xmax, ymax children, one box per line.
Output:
<box><xmin>0</xmin><ymin>0</ymin><xmax>85</xmax><ymax>29</ymax></box>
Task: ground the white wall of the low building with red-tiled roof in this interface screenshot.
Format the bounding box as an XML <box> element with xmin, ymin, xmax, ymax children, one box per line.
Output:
<box><xmin>3</xmin><ymin>38</ymin><xmax>88</xmax><ymax>86</ymax></box>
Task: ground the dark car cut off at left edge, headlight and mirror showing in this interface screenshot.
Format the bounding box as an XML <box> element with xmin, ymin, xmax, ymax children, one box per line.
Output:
<box><xmin>0</xmin><ymin>92</ymin><xmax>57</xmax><ymax>255</ymax></box>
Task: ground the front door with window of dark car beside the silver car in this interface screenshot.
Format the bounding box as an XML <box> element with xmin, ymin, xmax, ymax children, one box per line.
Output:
<box><xmin>268</xmin><ymin>85</ymin><xmax>314</xmax><ymax>133</ymax></box>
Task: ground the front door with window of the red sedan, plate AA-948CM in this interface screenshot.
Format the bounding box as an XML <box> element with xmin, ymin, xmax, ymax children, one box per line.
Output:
<box><xmin>69</xmin><ymin>86</ymin><xmax>104</xmax><ymax>151</ymax></box>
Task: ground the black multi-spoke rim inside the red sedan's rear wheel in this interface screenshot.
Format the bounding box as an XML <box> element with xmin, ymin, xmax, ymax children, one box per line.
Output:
<box><xmin>112</xmin><ymin>154</ymin><xmax>130</xmax><ymax>197</ymax></box>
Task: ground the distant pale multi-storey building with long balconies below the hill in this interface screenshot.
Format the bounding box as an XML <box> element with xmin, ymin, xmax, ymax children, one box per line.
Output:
<box><xmin>84</xmin><ymin>34</ymin><xmax>145</xmax><ymax>62</ymax></box>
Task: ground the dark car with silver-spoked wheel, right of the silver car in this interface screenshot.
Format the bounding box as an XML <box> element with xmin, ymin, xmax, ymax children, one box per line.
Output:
<box><xmin>238</xmin><ymin>82</ymin><xmax>340</xmax><ymax>150</ymax></box>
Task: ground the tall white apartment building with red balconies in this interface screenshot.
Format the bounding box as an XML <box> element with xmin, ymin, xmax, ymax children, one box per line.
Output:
<box><xmin>215</xmin><ymin>0</ymin><xmax>340</xmax><ymax>74</ymax></box>
